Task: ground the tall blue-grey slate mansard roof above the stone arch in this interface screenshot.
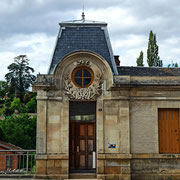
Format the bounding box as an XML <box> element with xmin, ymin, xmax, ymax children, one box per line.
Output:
<box><xmin>48</xmin><ymin>20</ymin><xmax>117</xmax><ymax>75</ymax></box>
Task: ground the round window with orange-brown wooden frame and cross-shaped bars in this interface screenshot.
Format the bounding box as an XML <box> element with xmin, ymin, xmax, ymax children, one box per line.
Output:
<box><xmin>72</xmin><ymin>66</ymin><xmax>94</xmax><ymax>88</ymax></box>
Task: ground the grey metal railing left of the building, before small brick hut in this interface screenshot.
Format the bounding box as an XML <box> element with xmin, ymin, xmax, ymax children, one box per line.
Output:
<box><xmin>0</xmin><ymin>150</ymin><xmax>36</xmax><ymax>174</ymax></box>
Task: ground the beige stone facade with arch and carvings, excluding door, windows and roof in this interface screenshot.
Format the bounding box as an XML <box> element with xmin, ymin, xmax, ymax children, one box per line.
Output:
<box><xmin>33</xmin><ymin>16</ymin><xmax>180</xmax><ymax>180</ymax></box>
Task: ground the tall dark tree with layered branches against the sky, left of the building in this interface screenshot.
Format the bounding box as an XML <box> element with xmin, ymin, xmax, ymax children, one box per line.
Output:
<box><xmin>5</xmin><ymin>55</ymin><xmax>36</xmax><ymax>99</ymax></box>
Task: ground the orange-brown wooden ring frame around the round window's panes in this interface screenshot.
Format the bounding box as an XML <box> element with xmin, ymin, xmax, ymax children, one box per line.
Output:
<box><xmin>71</xmin><ymin>66</ymin><xmax>94</xmax><ymax>88</ymax></box>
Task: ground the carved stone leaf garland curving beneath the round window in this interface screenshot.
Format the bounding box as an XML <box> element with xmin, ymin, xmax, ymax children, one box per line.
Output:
<box><xmin>64</xmin><ymin>74</ymin><xmax>102</xmax><ymax>100</ymax></box>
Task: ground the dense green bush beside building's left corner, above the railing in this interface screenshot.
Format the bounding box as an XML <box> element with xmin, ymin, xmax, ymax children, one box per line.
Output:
<box><xmin>0</xmin><ymin>114</ymin><xmax>36</xmax><ymax>149</ymax></box>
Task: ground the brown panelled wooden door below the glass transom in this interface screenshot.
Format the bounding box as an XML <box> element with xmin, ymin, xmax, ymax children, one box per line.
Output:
<box><xmin>69</xmin><ymin>121</ymin><xmax>96</xmax><ymax>172</ymax></box>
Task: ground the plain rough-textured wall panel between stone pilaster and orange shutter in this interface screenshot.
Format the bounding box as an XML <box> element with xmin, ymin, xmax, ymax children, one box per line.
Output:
<box><xmin>130</xmin><ymin>100</ymin><xmax>158</xmax><ymax>154</ymax></box>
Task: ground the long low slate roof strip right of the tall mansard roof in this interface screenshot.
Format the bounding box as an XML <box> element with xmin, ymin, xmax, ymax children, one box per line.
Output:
<box><xmin>117</xmin><ymin>66</ymin><xmax>180</xmax><ymax>76</ymax></box>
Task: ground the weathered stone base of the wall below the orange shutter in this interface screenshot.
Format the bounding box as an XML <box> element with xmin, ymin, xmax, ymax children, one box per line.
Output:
<box><xmin>131</xmin><ymin>154</ymin><xmax>180</xmax><ymax>180</ymax></box>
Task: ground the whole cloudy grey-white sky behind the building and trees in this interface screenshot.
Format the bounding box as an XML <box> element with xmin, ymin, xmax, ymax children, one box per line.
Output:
<box><xmin>0</xmin><ymin>0</ymin><xmax>180</xmax><ymax>80</ymax></box>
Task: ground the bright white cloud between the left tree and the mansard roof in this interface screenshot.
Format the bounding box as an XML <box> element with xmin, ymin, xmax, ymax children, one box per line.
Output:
<box><xmin>0</xmin><ymin>33</ymin><xmax>56</xmax><ymax>79</ymax></box>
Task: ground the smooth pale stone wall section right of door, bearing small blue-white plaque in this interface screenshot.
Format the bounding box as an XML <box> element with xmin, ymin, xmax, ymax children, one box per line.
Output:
<box><xmin>104</xmin><ymin>100</ymin><xmax>130</xmax><ymax>153</ymax></box>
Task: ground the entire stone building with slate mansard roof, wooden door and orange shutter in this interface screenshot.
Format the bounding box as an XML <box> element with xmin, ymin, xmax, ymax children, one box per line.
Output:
<box><xmin>33</xmin><ymin>16</ymin><xmax>180</xmax><ymax>180</ymax></box>
